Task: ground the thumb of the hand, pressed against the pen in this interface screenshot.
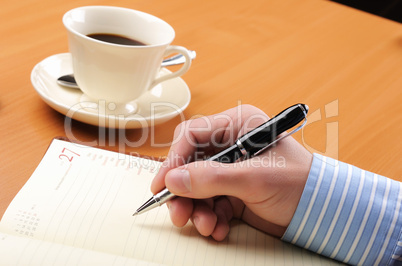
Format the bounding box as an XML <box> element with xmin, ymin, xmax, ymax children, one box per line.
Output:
<box><xmin>165</xmin><ymin>161</ymin><xmax>250</xmax><ymax>199</ymax></box>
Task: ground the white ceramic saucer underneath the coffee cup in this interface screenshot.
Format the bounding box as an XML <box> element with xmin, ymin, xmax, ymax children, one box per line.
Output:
<box><xmin>31</xmin><ymin>53</ymin><xmax>191</xmax><ymax>129</ymax></box>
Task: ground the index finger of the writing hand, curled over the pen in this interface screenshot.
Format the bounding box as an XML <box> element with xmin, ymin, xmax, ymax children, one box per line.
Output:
<box><xmin>151</xmin><ymin>105</ymin><xmax>268</xmax><ymax>193</ymax></box>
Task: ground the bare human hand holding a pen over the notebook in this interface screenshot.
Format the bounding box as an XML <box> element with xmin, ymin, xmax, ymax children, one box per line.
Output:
<box><xmin>151</xmin><ymin>105</ymin><xmax>312</xmax><ymax>241</ymax></box>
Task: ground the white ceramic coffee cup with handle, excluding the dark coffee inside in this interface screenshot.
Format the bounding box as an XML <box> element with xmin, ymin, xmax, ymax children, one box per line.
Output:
<box><xmin>63</xmin><ymin>6</ymin><xmax>191</xmax><ymax>111</ymax></box>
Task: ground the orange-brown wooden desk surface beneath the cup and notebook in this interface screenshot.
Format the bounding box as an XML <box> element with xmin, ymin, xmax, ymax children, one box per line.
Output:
<box><xmin>0</xmin><ymin>0</ymin><xmax>402</xmax><ymax>217</ymax></box>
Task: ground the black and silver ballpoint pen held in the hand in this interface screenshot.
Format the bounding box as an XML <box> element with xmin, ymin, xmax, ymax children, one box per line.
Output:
<box><xmin>133</xmin><ymin>103</ymin><xmax>308</xmax><ymax>216</ymax></box>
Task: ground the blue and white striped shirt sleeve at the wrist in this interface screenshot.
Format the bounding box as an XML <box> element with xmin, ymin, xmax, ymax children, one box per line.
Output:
<box><xmin>282</xmin><ymin>154</ymin><xmax>402</xmax><ymax>265</ymax></box>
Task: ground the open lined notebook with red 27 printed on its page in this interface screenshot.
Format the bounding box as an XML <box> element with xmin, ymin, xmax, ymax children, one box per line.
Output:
<box><xmin>0</xmin><ymin>139</ymin><xmax>336</xmax><ymax>265</ymax></box>
